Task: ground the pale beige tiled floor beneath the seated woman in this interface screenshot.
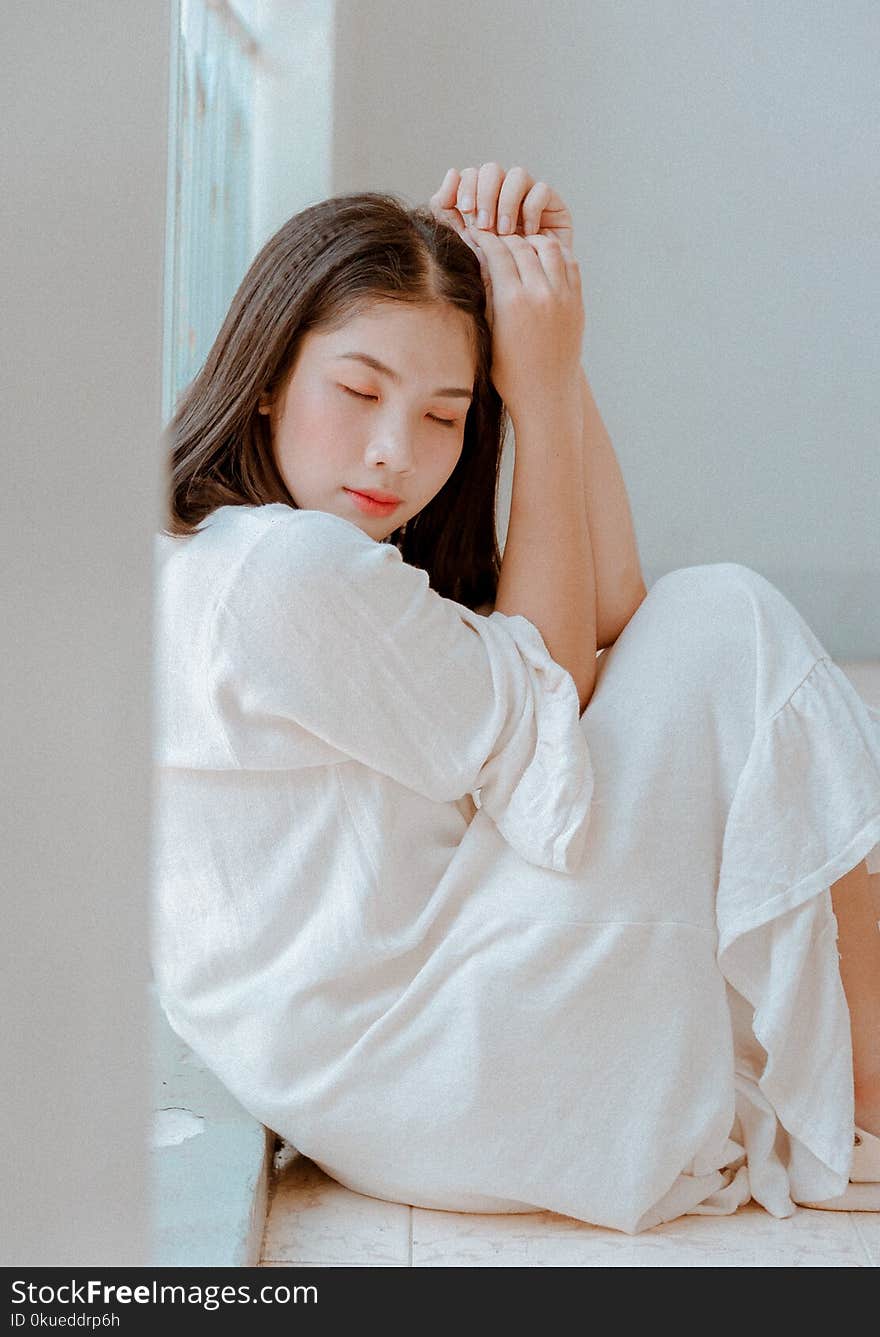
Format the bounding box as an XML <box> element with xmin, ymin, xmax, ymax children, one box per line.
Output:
<box><xmin>261</xmin><ymin>663</ymin><xmax>880</xmax><ymax>1267</ymax></box>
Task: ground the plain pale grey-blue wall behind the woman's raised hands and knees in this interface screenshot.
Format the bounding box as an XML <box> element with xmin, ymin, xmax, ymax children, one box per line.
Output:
<box><xmin>333</xmin><ymin>0</ymin><xmax>880</xmax><ymax>659</ymax></box>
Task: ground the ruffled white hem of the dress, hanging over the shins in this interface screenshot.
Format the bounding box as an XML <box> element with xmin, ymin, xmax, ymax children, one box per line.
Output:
<box><xmin>706</xmin><ymin>656</ymin><xmax>880</xmax><ymax>1217</ymax></box>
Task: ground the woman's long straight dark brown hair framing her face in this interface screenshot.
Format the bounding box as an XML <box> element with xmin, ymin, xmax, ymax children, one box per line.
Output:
<box><xmin>163</xmin><ymin>191</ymin><xmax>507</xmax><ymax>608</ymax></box>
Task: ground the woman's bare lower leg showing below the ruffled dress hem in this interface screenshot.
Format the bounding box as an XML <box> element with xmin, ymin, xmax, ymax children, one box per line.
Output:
<box><xmin>831</xmin><ymin>860</ymin><xmax>880</xmax><ymax>1136</ymax></box>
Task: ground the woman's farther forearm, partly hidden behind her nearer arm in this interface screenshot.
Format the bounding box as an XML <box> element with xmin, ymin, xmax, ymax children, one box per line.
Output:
<box><xmin>579</xmin><ymin>368</ymin><xmax>647</xmax><ymax>648</ymax></box>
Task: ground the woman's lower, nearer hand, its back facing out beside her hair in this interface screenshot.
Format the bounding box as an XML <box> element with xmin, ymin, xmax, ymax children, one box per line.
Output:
<box><xmin>468</xmin><ymin>229</ymin><xmax>584</xmax><ymax>424</ymax></box>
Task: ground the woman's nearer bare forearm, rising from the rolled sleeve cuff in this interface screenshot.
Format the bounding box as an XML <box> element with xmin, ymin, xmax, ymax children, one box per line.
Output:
<box><xmin>495</xmin><ymin>385</ymin><xmax>596</xmax><ymax>711</ymax></box>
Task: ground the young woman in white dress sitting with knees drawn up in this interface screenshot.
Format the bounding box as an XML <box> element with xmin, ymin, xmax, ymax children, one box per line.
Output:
<box><xmin>152</xmin><ymin>163</ymin><xmax>880</xmax><ymax>1233</ymax></box>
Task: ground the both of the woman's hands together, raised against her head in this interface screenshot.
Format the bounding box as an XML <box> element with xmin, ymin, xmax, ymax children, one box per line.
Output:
<box><xmin>431</xmin><ymin>163</ymin><xmax>584</xmax><ymax>414</ymax></box>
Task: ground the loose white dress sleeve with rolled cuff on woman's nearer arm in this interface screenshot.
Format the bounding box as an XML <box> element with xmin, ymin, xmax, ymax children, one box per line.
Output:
<box><xmin>209</xmin><ymin>508</ymin><xmax>594</xmax><ymax>872</ymax></box>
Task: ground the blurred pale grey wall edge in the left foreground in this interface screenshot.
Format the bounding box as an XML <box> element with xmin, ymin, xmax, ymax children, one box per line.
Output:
<box><xmin>0</xmin><ymin>0</ymin><xmax>170</xmax><ymax>1266</ymax></box>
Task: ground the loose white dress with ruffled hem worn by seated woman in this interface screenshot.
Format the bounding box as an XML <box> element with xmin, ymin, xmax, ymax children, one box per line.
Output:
<box><xmin>152</xmin><ymin>504</ymin><xmax>880</xmax><ymax>1234</ymax></box>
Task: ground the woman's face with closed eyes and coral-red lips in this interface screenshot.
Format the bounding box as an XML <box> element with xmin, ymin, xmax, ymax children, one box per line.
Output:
<box><xmin>259</xmin><ymin>302</ymin><xmax>476</xmax><ymax>541</ymax></box>
